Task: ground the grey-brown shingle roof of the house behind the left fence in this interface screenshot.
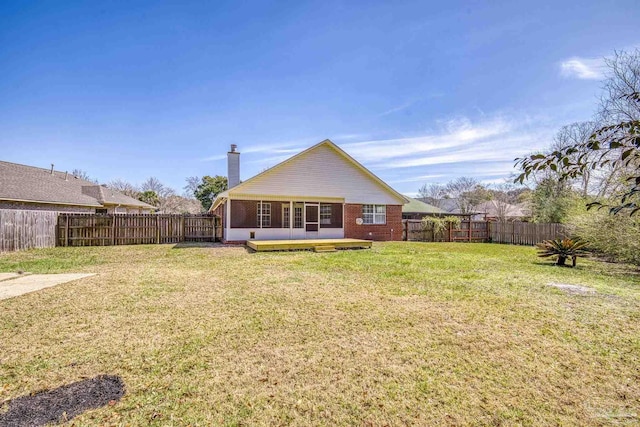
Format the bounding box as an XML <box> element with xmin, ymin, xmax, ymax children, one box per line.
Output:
<box><xmin>0</xmin><ymin>161</ymin><xmax>155</xmax><ymax>209</ymax></box>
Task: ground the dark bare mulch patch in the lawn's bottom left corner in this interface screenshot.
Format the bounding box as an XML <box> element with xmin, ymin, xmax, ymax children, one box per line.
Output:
<box><xmin>0</xmin><ymin>375</ymin><xmax>124</xmax><ymax>427</ymax></box>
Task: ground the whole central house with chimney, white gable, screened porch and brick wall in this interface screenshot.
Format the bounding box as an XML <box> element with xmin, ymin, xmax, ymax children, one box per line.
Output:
<box><xmin>210</xmin><ymin>139</ymin><xmax>408</xmax><ymax>243</ymax></box>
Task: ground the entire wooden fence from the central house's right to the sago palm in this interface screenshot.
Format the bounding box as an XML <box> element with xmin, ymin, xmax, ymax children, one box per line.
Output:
<box><xmin>402</xmin><ymin>219</ymin><xmax>566</xmax><ymax>245</ymax></box>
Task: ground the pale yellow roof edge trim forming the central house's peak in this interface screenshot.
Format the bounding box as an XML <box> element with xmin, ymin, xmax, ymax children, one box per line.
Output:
<box><xmin>210</xmin><ymin>139</ymin><xmax>408</xmax><ymax>210</ymax></box>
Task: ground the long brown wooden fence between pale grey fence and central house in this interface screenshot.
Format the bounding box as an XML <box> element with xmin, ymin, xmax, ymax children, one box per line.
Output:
<box><xmin>58</xmin><ymin>214</ymin><xmax>222</xmax><ymax>246</ymax></box>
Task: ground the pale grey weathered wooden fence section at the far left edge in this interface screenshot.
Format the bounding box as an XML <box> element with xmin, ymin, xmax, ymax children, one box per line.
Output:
<box><xmin>0</xmin><ymin>209</ymin><xmax>58</xmax><ymax>252</ymax></box>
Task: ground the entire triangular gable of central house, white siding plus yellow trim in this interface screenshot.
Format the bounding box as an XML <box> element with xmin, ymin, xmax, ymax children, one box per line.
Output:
<box><xmin>211</xmin><ymin>139</ymin><xmax>408</xmax><ymax>210</ymax></box>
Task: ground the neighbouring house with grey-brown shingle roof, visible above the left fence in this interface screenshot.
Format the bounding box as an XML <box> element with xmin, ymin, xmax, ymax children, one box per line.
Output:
<box><xmin>0</xmin><ymin>161</ymin><xmax>155</xmax><ymax>213</ymax></box>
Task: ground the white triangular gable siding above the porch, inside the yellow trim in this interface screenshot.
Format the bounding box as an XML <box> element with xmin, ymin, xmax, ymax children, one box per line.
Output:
<box><xmin>230</xmin><ymin>145</ymin><xmax>403</xmax><ymax>206</ymax></box>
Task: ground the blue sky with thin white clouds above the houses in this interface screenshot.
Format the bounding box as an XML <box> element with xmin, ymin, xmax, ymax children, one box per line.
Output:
<box><xmin>0</xmin><ymin>0</ymin><xmax>640</xmax><ymax>194</ymax></box>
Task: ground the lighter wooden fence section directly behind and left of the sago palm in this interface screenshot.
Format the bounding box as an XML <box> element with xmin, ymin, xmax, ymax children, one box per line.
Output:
<box><xmin>490</xmin><ymin>221</ymin><xmax>567</xmax><ymax>245</ymax></box>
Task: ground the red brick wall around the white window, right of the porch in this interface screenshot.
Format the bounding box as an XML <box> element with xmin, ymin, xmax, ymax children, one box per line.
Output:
<box><xmin>344</xmin><ymin>204</ymin><xmax>402</xmax><ymax>241</ymax></box>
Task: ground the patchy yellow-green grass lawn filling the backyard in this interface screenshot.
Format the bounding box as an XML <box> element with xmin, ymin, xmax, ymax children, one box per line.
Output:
<box><xmin>0</xmin><ymin>243</ymin><xmax>640</xmax><ymax>426</ymax></box>
